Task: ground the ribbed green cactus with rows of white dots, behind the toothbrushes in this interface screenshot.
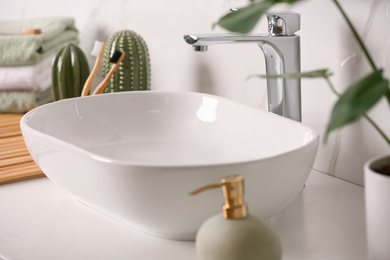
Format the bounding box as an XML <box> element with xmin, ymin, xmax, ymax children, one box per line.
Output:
<box><xmin>103</xmin><ymin>30</ymin><xmax>150</xmax><ymax>93</ymax></box>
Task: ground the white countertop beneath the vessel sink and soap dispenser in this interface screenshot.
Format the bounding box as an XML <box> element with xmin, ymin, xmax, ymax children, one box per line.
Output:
<box><xmin>0</xmin><ymin>171</ymin><xmax>367</xmax><ymax>260</ymax></box>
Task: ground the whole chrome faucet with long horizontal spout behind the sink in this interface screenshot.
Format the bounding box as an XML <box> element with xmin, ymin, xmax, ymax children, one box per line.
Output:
<box><xmin>184</xmin><ymin>12</ymin><xmax>301</xmax><ymax>121</ymax></box>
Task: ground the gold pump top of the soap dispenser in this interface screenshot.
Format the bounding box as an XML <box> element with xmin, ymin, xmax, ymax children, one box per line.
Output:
<box><xmin>190</xmin><ymin>175</ymin><xmax>248</xmax><ymax>219</ymax></box>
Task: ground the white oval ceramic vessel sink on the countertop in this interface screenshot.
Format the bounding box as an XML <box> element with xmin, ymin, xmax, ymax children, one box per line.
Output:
<box><xmin>20</xmin><ymin>91</ymin><xmax>318</xmax><ymax>240</ymax></box>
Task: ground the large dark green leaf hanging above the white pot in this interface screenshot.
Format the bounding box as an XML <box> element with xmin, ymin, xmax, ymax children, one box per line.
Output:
<box><xmin>325</xmin><ymin>70</ymin><xmax>389</xmax><ymax>140</ymax></box>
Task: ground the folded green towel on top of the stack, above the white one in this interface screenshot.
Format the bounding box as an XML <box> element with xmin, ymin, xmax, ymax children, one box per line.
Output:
<box><xmin>0</xmin><ymin>17</ymin><xmax>79</xmax><ymax>66</ymax></box>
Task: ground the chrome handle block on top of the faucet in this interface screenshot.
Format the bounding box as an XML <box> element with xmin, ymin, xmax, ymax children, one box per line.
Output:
<box><xmin>267</xmin><ymin>11</ymin><xmax>301</xmax><ymax>36</ymax></box>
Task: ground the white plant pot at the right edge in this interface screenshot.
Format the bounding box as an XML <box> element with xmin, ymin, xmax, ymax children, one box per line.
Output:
<box><xmin>364</xmin><ymin>156</ymin><xmax>390</xmax><ymax>260</ymax></box>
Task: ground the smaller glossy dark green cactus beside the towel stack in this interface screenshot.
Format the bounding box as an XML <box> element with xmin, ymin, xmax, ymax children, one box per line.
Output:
<box><xmin>52</xmin><ymin>44</ymin><xmax>89</xmax><ymax>101</ymax></box>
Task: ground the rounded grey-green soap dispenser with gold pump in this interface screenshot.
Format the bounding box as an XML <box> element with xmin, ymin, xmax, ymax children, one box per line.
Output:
<box><xmin>190</xmin><ymin>176</ymin><xmax>282</xmax><ymax>260</ymax></box>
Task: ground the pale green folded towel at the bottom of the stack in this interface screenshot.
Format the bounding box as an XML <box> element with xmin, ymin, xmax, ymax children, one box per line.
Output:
<box><xmin>0</xmin><ymin>88</ymin><xmax>53</xmax><ymax>113</ymax></box>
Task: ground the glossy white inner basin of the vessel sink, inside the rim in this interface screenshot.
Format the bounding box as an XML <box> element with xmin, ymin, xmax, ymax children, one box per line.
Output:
<box><xmin>26</xmin><ymin>90</ymin><xmax>313</xmax><ymax>166</ymax></box>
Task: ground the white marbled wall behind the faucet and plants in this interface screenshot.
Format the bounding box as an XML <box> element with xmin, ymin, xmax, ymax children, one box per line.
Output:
<box><xmin>0</xmin><ymin>0</ymin><xmax>390</xmax><ymax>185</ymax></box>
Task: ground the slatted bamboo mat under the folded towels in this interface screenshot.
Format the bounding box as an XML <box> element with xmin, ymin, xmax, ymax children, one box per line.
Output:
<box><xmin>0</xmin><ymin>113</ymin><xmax>45</xmax><ymax>185</ymax></box>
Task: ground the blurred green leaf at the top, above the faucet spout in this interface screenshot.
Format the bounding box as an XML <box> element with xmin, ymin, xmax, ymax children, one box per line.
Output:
<box><xmin>214</xmin><ymin>1</ymin><xmax>273</xmax><ymax>33</ymax></box>
